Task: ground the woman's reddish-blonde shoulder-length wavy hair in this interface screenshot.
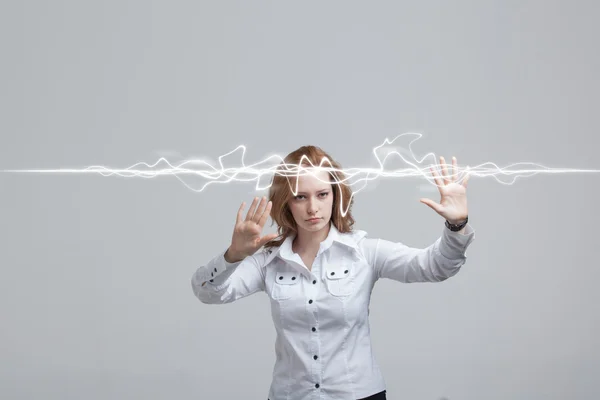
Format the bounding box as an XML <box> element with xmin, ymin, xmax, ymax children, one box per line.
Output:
<box><xmin>264</xmin><ymin>146</ymin><xmax>354</xmax><ymax>249</ymax></box>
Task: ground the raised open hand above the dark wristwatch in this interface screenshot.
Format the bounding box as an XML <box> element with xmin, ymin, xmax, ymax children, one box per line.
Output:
<box><xmin>419</xmin><ymin>157</ymin><xmax>469</xmax><ymax>224</ymax></box>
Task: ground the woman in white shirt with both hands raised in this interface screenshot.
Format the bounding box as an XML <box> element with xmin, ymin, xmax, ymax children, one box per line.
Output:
<box><xmin>192</xmin><ymin>146</ymin><xmax>474</xmax><ymax>400</ymax></box>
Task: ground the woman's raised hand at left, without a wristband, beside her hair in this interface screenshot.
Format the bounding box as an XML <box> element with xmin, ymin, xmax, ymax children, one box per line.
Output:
<box><xmin>225</xmin><ymin>196</ymin><xmax>279</xmax><ymax>262</ymax></box>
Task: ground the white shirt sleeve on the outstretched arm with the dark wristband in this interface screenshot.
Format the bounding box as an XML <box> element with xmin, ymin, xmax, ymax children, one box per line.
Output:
<box><xmin>361</xmin><ymin>224</ymin><xmax>475</xmax><ymax>283</ymax></box>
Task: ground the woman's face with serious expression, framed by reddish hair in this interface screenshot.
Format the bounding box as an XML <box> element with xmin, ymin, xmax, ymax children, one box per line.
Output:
<box><xmin>288</xmin><ymin>171</ymin><xmax>333</xmax><ymax>232</ymax></box>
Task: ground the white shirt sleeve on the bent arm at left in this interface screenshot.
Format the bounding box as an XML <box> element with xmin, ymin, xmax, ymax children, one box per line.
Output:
<box><xmin>191</xmin><ymin>250</ymin><xmax>266</xmax><ymax>304</ymax></box>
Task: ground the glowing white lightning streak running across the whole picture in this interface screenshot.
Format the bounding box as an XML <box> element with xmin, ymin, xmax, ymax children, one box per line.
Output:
<box><xmin>3</xmin><ymin>133</ymin><xmax>600</xmax><ymax>215</ymax></box>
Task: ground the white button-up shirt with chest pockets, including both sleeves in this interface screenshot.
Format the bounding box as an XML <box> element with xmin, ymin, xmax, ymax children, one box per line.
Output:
<box><xmin>192</xmin><ymin>224</ymin><xmax>475</xmax><ymax>400</ymax></box>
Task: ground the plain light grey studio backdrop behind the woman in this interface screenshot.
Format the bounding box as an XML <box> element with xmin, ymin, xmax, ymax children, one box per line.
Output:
<box><xmin>0</xmin><ymin>0</ymin><xmax>600</xmax><ymax>400</ymax></box>
